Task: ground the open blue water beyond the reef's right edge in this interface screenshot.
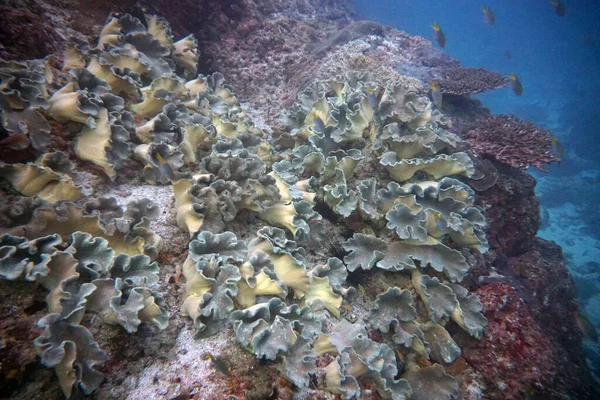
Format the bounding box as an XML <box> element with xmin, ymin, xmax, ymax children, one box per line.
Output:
<box><xmin>355</xmin><ymin>0</ymin><xmax>600</xmax><ymax>375</ymax></box>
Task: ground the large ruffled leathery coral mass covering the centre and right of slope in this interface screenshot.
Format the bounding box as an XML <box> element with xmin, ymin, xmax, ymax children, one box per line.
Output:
<box><xmin>175</xmin><ymin>73</ymin><xmax>487</xmax><ymax>399</ymax></box>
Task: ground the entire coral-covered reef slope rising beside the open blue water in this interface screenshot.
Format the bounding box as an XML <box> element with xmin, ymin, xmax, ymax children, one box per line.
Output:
<box><xmin>0</xmin><ymin>0</ymin><xmax>597</xmax><ymax>399</ymax></box>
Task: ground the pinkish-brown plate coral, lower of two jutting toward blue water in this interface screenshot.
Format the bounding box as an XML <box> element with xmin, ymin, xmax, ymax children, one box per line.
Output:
<box><xmin>465</xmin><ymin>115</ymin><xmax>560</xmax><ymax>171</ymax></box>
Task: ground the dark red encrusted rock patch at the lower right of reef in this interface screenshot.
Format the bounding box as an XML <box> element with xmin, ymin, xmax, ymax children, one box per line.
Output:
<box><xmin>463</xmin><ymin>284</ymin><xmax>557</xmax><ymax>400</ymax></box>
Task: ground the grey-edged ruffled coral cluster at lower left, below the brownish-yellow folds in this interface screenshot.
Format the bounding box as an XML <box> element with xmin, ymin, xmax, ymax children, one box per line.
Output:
<box><xmin>0</xmin><ymin>232</ymin><xmax>168</xmax><ymax>398</ymax></box>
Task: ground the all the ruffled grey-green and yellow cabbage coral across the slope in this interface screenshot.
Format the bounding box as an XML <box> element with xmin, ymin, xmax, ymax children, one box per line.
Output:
<box><xmin>0</xmin><ymin>15</ymin><xmax>487</xmax><ymax>399</ymax></box>
